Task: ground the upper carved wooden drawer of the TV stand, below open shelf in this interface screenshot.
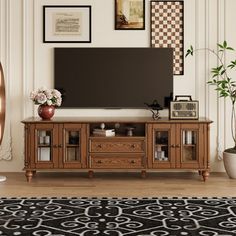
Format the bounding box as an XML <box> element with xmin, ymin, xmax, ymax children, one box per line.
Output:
<box><xmin>90</xmin><ymin>139</ymin><xmax>145</xmax><ymax>152</ymax></box>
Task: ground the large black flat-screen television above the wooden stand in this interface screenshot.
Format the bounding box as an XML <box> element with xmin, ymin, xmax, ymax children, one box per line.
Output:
<box><xmin>54</xmin><ymin>48</ymin><xmax>173</xmax><ymax>108</ymax></box>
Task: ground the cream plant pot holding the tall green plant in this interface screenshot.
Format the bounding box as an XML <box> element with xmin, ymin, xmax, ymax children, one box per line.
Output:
<box><xmin>223</xmin><ymin>149</ymin><xmax>236</xmax><ymax>179</ymax></box>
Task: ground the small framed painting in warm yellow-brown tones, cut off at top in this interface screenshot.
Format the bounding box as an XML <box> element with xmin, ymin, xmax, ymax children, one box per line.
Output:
<box><xmin>115</xmin><ymin>0</ymin><xmax>145</xmax><ymax>30</ymax></box>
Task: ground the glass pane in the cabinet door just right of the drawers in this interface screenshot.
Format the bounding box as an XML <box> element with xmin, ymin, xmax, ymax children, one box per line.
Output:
<box><xmin>154</xmin><ymin>131</ymin><xmax>169</xmax><ymax>161</ymax></box>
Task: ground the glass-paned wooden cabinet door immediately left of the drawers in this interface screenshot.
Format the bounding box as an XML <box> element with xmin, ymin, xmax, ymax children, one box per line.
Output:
<box><xmin>58</xmin><ymin>124</ymin><xmax>87</xmax><ymax>169</ymax></box>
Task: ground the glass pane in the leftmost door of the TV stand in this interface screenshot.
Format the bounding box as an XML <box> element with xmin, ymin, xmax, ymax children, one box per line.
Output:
<box><xmin>37</xmin><ymin>130</ymin><xmax>52</xmax><ymax>161</ymax></box>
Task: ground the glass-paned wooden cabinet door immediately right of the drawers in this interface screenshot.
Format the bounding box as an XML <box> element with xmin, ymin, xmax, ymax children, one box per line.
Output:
<box><xmin>148</xmin><ymin>124</ymin><xmax>176</xmax><ymax>169</ymax></box>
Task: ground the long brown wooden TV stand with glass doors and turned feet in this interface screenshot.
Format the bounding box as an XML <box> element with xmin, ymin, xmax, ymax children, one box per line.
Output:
<box><xmin>22</xmin><ymin>117</ymin><xmax>211</xmax><ymax>182</ymax></box>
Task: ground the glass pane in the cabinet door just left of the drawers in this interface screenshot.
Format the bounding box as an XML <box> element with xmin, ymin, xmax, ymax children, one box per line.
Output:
<box><xmin>65</xmin><ymin>130</ymin><xmax>80</xmax><ymax>162</ymax></box>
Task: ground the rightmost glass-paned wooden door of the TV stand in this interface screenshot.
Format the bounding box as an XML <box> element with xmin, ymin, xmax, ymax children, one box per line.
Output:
<box><xmin>175</xmin><ymin>124</ymin><xmax>205</xmax><ymax>169</ymax></box>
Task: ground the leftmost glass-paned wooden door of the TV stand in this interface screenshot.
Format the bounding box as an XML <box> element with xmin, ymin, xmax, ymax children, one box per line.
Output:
<box><xmin>30</xmin><ymin>124</ymin><xmax>59</xmax><ymax>169</ymax></box>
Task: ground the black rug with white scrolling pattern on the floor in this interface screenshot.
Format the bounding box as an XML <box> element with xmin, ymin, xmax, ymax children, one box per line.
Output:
<box><xmin>0</xmin><ymin>198</ymin><xmax>236</xmax><ymax>236</ymax></box>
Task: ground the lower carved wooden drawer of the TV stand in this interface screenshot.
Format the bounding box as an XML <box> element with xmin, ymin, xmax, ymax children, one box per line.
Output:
<box><xmin>90</xmin><ymin>154</ymin><xmax>145</xmax><ymax>169</ymax></box>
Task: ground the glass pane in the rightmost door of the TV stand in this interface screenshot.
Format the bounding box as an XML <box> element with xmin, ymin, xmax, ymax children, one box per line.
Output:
<box><xmin>182</xmin><ymin>130</ymin><xmax>197</xmax><ymax>162</ymax></box>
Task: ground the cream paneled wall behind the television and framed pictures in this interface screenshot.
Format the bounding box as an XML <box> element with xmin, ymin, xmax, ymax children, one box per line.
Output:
<box><xmin>0</xmin><ymin>0</ymin><xmax>236</xmax><ymax>172</ymax></box>
